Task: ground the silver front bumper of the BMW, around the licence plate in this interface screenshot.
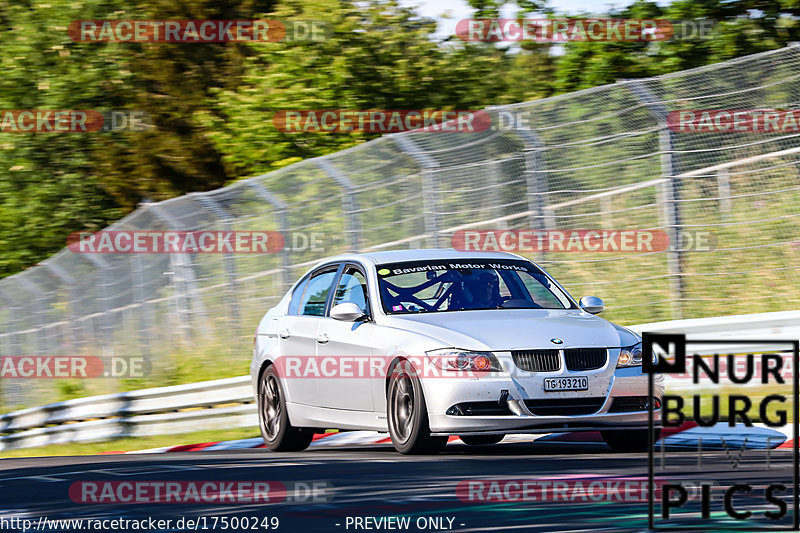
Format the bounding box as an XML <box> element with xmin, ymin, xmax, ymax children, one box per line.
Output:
<box><xmin>421</xmin><ymin>357</ymin><xmax>664</xmax><ymax>435</ymax></box>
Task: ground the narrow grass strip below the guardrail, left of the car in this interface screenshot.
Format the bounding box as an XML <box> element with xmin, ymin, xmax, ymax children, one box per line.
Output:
<box><xmin>0</xmin><ymin>427</ymin><xmax>260</xmax><ymax>459</ymax></box>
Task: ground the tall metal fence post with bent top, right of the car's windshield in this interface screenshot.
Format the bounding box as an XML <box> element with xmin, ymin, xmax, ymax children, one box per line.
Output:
<box><xmin>624</xmin><ymin>80</ymin><xmax>684</xmax><ymax>320</ymax></box>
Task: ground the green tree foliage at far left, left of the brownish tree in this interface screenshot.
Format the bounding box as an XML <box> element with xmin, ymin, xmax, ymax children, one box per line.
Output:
<box><xmin>0</xmin><ymin>1</ymin><xmax>125</xmax><ymax>275</ymax></box>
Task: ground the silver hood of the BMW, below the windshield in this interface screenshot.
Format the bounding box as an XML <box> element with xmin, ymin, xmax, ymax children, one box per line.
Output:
<box><xmin>385</xmin><ymin>309</ymin><xmax>639</xmax><ymax>351</ymax></box>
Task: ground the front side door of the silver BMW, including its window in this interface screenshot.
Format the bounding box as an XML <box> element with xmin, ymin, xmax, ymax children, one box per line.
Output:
<box><xmin>317</xmin><ymin>264</ymin><xmax>375</xmax><ymax>411</ymax></box>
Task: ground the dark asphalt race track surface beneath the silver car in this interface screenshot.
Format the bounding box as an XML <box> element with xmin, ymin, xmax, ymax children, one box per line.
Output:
<box><xmin>0</xmin><ymin>442</ymin><xmax>793</xmax><ymax>533</ymax></box>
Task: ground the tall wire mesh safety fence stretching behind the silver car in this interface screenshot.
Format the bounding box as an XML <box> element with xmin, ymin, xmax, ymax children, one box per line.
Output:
<box><xmin>0</xmin><ymin>46</ymin><xmax>800</xmax><ymax>411</ymax></box>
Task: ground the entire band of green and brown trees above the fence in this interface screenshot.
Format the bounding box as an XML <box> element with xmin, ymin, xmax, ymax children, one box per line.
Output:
<box><xmin>0</xmin><ymin>0</ymin><xmax>800</xmax><ymax>276</ymax></box>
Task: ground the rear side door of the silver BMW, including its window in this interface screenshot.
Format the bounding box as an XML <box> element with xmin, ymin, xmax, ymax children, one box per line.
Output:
<box><xmin>278</xmin><ymin>264</ymin><xmax>340</xmax><ymax>405</ymax></box>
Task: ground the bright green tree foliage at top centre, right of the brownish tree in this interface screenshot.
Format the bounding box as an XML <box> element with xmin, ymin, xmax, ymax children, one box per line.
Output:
<box><xmin>205</xmin><ymin>0</ymin><xmax>510</xmax><ymax>176</ymax></box>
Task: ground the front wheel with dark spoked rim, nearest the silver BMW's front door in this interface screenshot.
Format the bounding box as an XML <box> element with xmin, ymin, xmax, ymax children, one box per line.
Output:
<box><xmin>386</xmin><ymin>361</ymin><xmax>447</xmax><ymax>454</ymax></box>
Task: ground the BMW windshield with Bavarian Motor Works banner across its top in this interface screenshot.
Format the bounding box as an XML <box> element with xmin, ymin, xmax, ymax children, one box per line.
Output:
<box><xmin>377</xmin><ymin>259</ymin><xmax>574</xmax><ymax>314</ymax></box>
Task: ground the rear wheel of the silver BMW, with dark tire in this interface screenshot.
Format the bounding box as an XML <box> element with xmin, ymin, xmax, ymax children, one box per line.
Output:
<box><xmin>258</xmin><ymin>367</ymin><xmax>314</xmax><ymax>452</ymax></box>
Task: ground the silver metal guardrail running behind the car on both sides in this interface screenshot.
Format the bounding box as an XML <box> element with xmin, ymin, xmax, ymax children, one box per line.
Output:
<box><xmin>0</xmin><ymin>311</ymin><xmax>800</xmax><ymax>451</ymax></box>
